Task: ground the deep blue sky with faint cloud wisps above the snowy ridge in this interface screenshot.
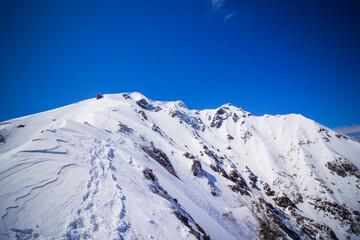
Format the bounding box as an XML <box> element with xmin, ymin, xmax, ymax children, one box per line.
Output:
<box><xmin>0</xmin><ymin>0</ymin><xmax>360</xmax><ymax>127</ymax></box>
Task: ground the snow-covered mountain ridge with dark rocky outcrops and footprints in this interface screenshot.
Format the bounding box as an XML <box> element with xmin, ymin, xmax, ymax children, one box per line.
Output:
<box><xmin>0</xmin><ymin>93</ymin><xmax>360</xmax><ymax>240</ymax></box>
